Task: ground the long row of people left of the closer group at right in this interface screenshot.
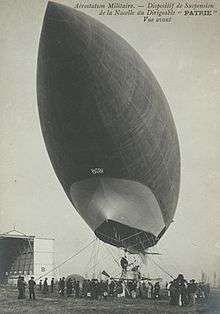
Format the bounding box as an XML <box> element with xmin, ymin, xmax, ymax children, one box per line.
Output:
<box><xmin>17</xmin><ymin>276</ymin><xmax>160</xmax><ymax>300</ymax></box>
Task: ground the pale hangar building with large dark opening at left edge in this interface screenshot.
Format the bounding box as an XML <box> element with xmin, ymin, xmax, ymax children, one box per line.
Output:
<box><xmin>0</xmin><ymin>230</ymin><xmax>55</xmax><ymax>284</ymax></box>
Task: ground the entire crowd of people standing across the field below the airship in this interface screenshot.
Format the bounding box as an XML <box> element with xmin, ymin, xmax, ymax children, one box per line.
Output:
<box><xmin>17</xmin><ymin>274</ymin><xmax>210</xmax><ymax>306</ymax></box>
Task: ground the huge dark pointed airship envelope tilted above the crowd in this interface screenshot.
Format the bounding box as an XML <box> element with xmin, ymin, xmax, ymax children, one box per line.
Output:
<box><xmin>37</xmin><ymin>2</ymin><xmax>180</xmax><ymax>253</ymax></box>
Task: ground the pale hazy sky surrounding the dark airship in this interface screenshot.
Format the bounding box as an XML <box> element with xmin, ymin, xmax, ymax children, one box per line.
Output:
<box><xmin>0</xmin><ymin>0</ymin><xmax>220</xmax><ymax>280</ymax></box>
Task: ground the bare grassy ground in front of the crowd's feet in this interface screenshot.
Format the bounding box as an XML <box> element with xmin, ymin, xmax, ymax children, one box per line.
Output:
<box><xmin>0</xmin><ymin>287</ymin><xmax>220</xmax><ymax>314</ymax></box>
